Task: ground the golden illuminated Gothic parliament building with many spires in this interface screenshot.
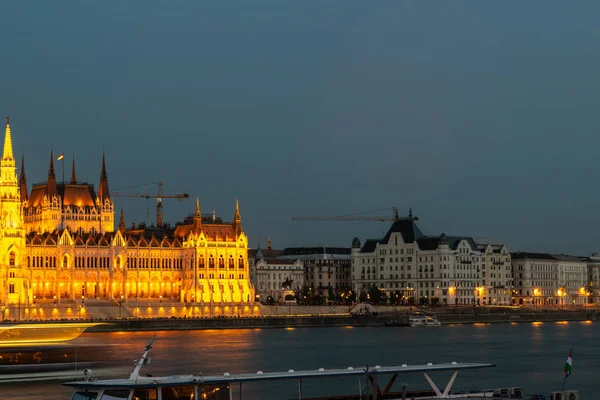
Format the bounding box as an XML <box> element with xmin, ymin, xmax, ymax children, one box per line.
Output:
<box><xmin>0</xmin><ymin>118</ymin><xmax>254</xmax><ymax>305</ymax></box>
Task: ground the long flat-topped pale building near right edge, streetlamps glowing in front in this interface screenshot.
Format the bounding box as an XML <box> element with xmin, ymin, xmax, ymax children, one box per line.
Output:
<box><xmin>511</xmin><ymin>252</ymin><xmax>588</xmax><ymax>306</ymax></box>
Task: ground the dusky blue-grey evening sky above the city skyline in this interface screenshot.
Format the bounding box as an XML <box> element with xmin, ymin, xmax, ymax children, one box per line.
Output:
<box><xmin>0</xmin><ymin>0</ymin><xmax>600</xmax><ymax>254</ymax></box>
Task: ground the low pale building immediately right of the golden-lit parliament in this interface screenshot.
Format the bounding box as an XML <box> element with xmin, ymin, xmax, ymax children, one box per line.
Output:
<box><xmin>255</xmin><ymin>259</ymin><xmax>304</xmax><ymax>302</ymax></box>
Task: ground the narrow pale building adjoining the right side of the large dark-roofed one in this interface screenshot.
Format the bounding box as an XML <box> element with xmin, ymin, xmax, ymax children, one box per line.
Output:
<box><xmin>476</xmin><ymin>240</ymin><xmax>513</xmax><ymax>305</ymax></box>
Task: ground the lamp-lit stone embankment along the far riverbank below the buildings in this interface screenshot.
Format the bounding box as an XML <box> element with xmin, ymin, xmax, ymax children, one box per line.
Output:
<box><xmin>2</xmin><ymin>302</ymin><xmax>600</xmax><ymax>331</ymax></box>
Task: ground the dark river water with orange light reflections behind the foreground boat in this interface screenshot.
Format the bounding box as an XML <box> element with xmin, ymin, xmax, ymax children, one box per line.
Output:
<box><xmin>0</xmin><ymin>322</ymin><xmax>600</xmax><ymax>400</ymax></box>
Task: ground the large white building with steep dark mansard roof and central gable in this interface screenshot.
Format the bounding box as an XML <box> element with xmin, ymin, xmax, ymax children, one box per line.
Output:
<box><xmin>352</xmin><ymin>217</ymin><xmax>482</xmax><ymax>305</ymax></box>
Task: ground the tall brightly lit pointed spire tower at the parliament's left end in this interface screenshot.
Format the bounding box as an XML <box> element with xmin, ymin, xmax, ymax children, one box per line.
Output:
<box><xmin>0</xmin><ymin>117</ymin><xmax>29</xmax><ymax>305</ymax></box>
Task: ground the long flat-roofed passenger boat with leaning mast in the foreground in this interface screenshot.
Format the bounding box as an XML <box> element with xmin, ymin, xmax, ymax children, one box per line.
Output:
<box><xmin>64</xmin><ymin>337</ymin><xmax>576</xmax><ymax>400</ymax></box>
